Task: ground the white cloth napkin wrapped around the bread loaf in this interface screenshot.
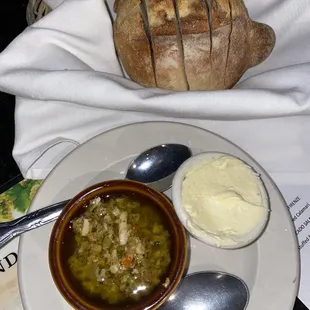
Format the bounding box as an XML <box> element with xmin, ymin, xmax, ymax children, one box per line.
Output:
<box><xmin>0</xmin><ymin>0</ymin><xmax>310</xmax><ymax>184</ymax></box>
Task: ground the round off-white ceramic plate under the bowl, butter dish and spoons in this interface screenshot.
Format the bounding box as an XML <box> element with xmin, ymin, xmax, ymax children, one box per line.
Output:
<box><xmin>18</xmin><ymin>122</ymin><xmax>299</xmax><ymax>310</ymax></box>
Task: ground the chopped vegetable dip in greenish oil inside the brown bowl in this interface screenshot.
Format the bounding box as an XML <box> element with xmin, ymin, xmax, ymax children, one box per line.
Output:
<box><xmin>69</xmin><ymin>196</ymin><xmax>171</xmax><ymax>304</ymax></box>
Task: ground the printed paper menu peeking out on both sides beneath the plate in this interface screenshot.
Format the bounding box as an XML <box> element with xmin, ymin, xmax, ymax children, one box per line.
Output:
<box><xmin>0</xmin><ymin>180</ymin><xmax>310</xmax><ymax>310</ymax></box>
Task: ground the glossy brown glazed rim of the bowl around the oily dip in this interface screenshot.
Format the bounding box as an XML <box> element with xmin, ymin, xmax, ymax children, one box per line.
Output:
<box><xmin>48</xmin><ymin>180</ymin><xmax>187</xmax><ymax>310</ymax></box>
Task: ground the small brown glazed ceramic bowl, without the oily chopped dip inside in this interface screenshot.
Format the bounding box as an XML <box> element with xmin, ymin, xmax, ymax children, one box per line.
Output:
<box><xmin>49</xmin><ymin>180</ymin><xmax>187</xmax><ymax>310</ymax></box>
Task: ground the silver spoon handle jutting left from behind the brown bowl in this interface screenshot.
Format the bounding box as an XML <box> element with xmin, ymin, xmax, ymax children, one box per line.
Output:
<box><xmin>0</xmin><ymin>200</ymin><xmax>70</xmax><ymax>249</ymax></box>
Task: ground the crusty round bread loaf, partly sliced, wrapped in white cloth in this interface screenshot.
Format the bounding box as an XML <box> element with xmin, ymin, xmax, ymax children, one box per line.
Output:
<box><xmin>113</xmin><ymin>0</ymin><xmax>275</xmax><ymax>91</ymax></box>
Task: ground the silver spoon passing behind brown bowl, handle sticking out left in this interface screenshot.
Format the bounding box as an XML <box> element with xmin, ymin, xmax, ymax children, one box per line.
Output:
<box><xmin>0</xmin><ymin>144</ymin><xmax>192</xmax><ymax>249</ymax></box>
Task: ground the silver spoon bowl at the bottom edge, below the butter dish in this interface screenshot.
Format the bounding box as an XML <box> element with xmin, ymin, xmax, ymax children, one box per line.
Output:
<box><xmin>160</xmin><ymin>271</ymin><xmax>250</xmax><ymax>310</ymax></box>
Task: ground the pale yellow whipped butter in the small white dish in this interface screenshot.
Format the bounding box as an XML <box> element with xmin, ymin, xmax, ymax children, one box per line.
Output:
<box><xmin>182</xmin><ymin>155</ymin><xmax>266</xmax><ymax>246</ymax></box>
